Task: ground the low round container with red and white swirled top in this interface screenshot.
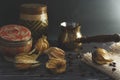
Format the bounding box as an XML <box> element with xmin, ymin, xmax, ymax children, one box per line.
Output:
<box><xmin>0</xmin><ymin>24</ymin><xmax>32</xmax><ymax>61</ymax></box>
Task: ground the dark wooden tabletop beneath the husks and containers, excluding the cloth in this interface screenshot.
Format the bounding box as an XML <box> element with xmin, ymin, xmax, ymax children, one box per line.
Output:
<box><xmin>0</xmin><ymin>43</ymin><xmax>113</xmax><ymax>80</ymax></box>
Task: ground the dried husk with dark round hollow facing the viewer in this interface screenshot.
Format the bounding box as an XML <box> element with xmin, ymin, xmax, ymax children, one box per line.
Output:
<box><xmin>46</xmin><ymin>58</ymin><xmax>66</xmax><ymax>73</ymax></box>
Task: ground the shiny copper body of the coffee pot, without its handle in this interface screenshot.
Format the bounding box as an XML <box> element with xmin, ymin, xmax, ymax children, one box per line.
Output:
<box><xmin>58</xmin><ymin>22</ymin><xmax>82</xmax><ymax>49</ymax></box>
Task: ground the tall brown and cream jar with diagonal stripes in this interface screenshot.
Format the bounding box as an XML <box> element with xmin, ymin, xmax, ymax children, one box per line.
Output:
<box><xmin>20</xmin><ymin>4</ymin><xmax>48</xmax><ymax>40</ymax></box>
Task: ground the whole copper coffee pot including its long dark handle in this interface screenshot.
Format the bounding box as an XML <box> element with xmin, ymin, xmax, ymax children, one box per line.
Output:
<box><xmin>58</xmin><ymin>22</ymin><xmax>120</xmax><ymax>50</ymax></box>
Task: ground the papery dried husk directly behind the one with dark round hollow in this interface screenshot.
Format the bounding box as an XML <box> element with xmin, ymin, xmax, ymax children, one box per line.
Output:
<box><xmin>44</xmin><ymin>47</ymin><xmax>65</xmax><ymax>59</ymax></box>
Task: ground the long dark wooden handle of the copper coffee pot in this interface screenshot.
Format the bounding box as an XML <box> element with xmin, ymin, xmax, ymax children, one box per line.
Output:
<box><xmin>75</xmin><ymin>34</ymin><xmax>120</xmax><ymax>43</ymax></box>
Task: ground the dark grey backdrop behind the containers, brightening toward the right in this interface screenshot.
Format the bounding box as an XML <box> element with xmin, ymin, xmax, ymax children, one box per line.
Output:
<box><xmin>0</xmin><ymin>0</ymin><xmax>120</xmax><ymax>40</ymax></box>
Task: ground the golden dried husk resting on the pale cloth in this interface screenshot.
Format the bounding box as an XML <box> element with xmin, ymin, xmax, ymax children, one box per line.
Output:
<box><xmin>92</xmin><ymin>48</ymin><xmax>113</xmax><ymax>64</ymax></box>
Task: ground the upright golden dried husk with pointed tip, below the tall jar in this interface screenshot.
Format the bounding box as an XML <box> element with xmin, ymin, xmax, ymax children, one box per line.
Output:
<box><xmin>35</xmin><ymin>35</ymin><xmax>49</xmax><ymax>52</ymax></box>
